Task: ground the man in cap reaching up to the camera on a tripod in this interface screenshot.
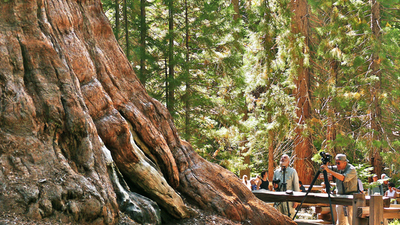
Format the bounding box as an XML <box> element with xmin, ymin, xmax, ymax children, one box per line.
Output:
<box><xmin>321</xmin><ymin>154</ymin><xmax>358</xmax><ymax>225</ymax></box>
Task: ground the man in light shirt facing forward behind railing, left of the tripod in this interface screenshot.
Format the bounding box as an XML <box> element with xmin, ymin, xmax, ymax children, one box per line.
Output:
<box><xmin>273</xmin><ymin>154</ymin><xmax>300</xmax><ymax>217</ymax></box>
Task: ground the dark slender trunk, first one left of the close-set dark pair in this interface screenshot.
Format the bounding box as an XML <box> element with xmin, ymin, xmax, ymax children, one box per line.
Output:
<box><xmin>139</xmin><ymin>0</ymin><xmax>147</xmax><ymax>87</ymax></box>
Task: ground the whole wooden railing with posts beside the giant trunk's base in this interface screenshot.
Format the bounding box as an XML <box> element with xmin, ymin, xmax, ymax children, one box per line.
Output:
<box><xmin>253</xmin><ymin>190</ymin><xmax>400</xmax><ymax>225</ymax></box>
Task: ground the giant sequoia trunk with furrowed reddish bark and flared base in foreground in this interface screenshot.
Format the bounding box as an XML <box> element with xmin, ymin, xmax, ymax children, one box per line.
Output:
<box><xmin>0</xmin><ymin>0</ymin><xmax>293</xmax><ymax>224</ymax></box>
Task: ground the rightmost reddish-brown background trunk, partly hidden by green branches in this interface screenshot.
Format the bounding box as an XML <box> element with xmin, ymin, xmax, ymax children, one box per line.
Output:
<box><xmin>370</xmin><ymin>0</ymin><xmax>383</xmax><ymax>175</ymax></box>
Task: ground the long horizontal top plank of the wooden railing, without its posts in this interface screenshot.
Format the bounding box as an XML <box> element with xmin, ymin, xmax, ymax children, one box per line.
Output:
<box><xmin>252</xmin><ymin>189</ymin><xmax>390</xmax><ymax>207</ymax></box>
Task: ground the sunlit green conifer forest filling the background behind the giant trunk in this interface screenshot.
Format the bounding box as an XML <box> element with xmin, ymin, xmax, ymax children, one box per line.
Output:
<box><xmin>102</xmin><ymin>0</ymin><xmax>400</xmax><ymax>186</ymax></box>
